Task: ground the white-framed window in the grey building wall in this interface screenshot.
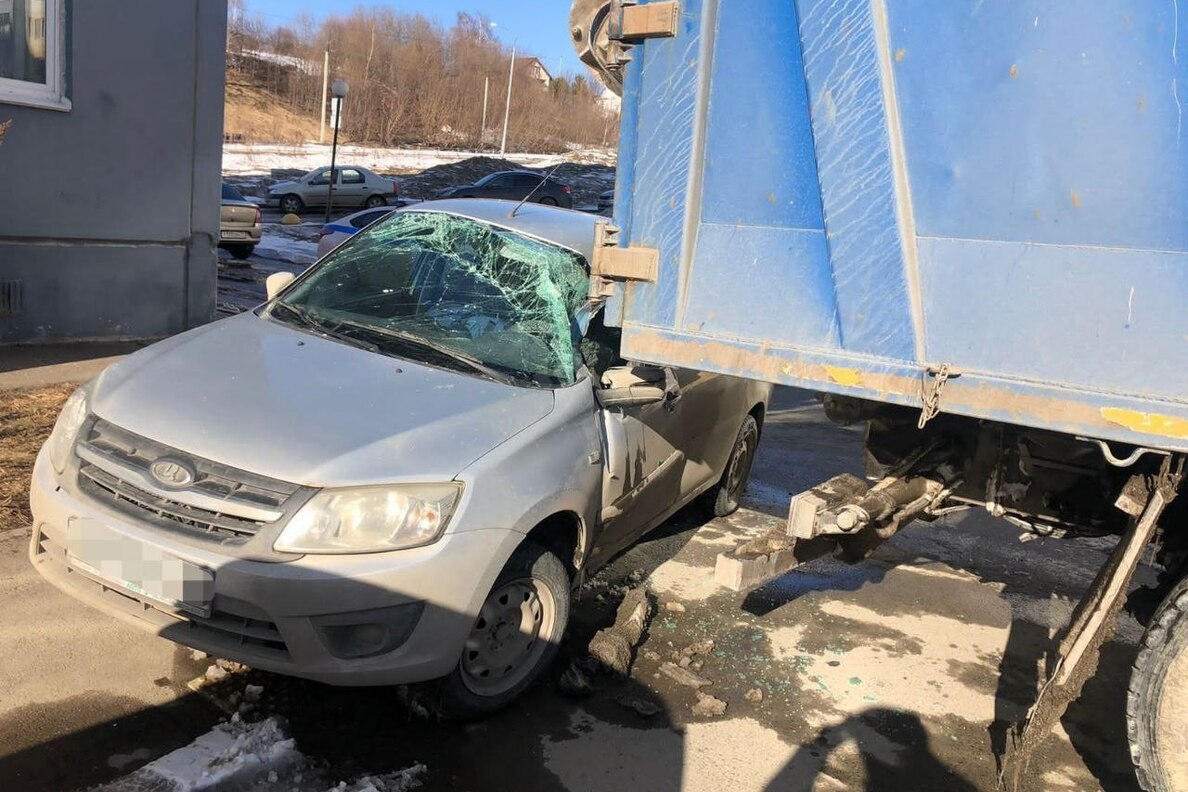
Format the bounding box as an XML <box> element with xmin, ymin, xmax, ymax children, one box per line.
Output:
<box><xmin>0</xmin><ymin>0</ymin><xmax>70</xmax><ymax>110</ymax></box>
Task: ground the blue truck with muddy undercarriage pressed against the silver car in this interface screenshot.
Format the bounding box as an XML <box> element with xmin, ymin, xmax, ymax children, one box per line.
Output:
<box><xmin>570</xmin><ymin>0</ymin><xmax>1188</xmax><ymax>792</ymax></box>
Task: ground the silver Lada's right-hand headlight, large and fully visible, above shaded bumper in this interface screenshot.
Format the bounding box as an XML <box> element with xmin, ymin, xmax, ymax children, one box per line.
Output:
<box><xmin>273</xmin><ymin>483</ymin><xmax>462</xmax><ymax>553</ymax></box>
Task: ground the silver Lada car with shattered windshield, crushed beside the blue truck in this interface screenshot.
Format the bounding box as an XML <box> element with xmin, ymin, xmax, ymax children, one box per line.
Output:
<box><xmin>31</xmin><ymin>201</ymin><xmax>770</xmax><ymax>716</ymax></box>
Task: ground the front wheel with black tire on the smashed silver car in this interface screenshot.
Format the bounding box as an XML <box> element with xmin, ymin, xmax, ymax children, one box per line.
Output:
<box><xmin>438</xmin><ymin>540</ymin><xmax>570</xmax><ymax>720</ymax></box>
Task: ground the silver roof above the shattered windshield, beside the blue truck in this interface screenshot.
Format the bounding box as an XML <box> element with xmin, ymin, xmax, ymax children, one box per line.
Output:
<box><xmin>402</xmin><ymin>198</ymin><xmax>606</xmax><ymax>262</ymax></box>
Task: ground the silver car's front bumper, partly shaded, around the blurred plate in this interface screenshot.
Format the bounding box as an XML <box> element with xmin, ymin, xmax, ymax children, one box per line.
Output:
<box><xmin>30</xmin><ymin>451</ymin><xmax>523</xmax><ymax>685</ymax></box>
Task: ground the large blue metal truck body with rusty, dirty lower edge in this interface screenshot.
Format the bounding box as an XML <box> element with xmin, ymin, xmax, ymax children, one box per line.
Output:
<box><xmin>603</xmin><ymin>0</ymin><xmax>1188</xmax><ymax>450</ymax></box>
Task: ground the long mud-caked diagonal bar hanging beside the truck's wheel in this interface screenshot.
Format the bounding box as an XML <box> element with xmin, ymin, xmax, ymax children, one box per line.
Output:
<box><xmin>998</xmin><ymin>457</ymin><xmax>1184</xmax><ymax>791</ymax></box>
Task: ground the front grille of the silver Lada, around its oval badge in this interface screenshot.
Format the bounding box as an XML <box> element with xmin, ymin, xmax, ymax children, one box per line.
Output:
<box><xmin>76</xmin><ymin>420</ymin><xmax>304</xmax><ymax>544</ymax></box>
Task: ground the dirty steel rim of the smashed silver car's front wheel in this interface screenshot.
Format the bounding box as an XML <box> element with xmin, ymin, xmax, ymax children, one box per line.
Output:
<box><xmin>459</xmin><ymin>577</ymin><xmax>557</xmax><ymax>696</ymax></box>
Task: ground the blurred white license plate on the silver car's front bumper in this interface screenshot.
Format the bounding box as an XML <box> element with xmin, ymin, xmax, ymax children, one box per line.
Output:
<box><xmin>67</xmin><ymin>520</ymin><xmax>215</xmax><ymax>616</ymax></box>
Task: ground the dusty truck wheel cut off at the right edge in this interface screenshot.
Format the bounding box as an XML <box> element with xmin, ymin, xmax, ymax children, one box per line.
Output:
<box><xmin>1126</xmin><ymin>578</ymin><xmax>1188</xmax><ymax>792</ymax></box>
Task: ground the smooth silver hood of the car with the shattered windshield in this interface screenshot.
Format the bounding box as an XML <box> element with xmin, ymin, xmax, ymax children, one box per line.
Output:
<box><xmin>91</xmin><ymin>313</ymin><xmax>554</xmax><ymax>487</ymax></box>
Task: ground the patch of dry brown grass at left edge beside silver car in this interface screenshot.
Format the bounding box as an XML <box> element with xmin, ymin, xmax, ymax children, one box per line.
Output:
<box><xmin>0</xmin><ymin>384</ymin><xmax>77</xmax><ymax>530</ymax></box>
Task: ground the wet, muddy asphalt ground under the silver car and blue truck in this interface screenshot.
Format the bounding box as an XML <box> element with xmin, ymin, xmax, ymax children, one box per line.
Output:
<box><xmin>0</xmin><ymin>391</ymin><xmax>1139</xmax><ymax>792</ymax></box>
